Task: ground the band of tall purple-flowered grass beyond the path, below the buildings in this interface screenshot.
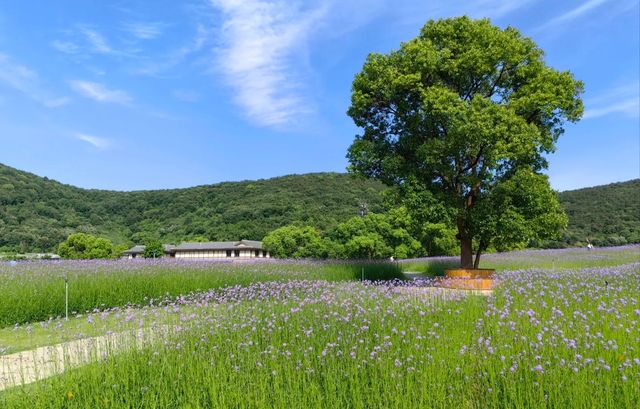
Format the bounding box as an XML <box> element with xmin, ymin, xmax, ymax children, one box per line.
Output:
<box><xmin>0</xmin><ymin>259</ymin><xmax>401</xmax><ymax>327</ymax></box>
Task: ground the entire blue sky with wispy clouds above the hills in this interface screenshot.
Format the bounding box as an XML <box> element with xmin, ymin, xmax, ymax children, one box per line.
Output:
<box><xmin>0</xmin><ymin>0</ymin><xmax>640</xmax><ymax>190</ymax></box>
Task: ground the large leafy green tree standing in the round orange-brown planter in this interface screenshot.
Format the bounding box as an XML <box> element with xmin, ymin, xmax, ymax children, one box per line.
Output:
<box><xmin>347</xmin><ymin>17</ymin><xmax>583</xmax><ymax>268</ymax></box>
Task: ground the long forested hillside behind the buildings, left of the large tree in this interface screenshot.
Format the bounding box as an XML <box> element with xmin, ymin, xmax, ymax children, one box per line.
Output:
<box><xmin>0</xmin><ymin>164</ymin><xmax>384</xmax><ymax>252</ymax></box>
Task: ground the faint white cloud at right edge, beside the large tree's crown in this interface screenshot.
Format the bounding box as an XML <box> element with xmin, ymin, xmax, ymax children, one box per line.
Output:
<box><xmin>583</xmin><ymin>81</ymin><xmax>640</xmax><ymax>119</ymax></box>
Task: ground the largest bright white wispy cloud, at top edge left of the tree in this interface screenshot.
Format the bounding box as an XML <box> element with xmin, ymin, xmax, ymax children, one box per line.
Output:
<box><xmin>212</xmin><ymin>0</ymin><xmax>326</xmax><ymax>126</ymax></box>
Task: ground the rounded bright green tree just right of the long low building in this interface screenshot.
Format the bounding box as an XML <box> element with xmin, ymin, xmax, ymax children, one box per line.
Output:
<box><xmin>262</xmin><ymin>225</ymin><xmax>327</xmax><ymax>258</ymax></box>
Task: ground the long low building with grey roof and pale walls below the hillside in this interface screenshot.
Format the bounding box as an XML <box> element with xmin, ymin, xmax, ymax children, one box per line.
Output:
<box><xmin>123</xmin><ymin>240</ymin><xmax>270</xmax><ymax>259</ymax></box>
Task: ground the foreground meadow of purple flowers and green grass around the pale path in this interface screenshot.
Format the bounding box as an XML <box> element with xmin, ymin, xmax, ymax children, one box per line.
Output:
<box><xmin>0</xmin><ymin>247</ymin><xmax>640</xmax><ymax>408</ymax></box>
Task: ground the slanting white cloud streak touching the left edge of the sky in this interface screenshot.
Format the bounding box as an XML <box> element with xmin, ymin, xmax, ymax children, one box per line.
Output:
<box><xmin>0</xmin><ymin>53</ymin><xmax>70</xmax><ymax>108</ymax></box>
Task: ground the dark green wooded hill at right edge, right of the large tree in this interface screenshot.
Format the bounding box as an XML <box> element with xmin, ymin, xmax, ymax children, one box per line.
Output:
<box><xmin>555</xmin><ymin>179</ymin><xmax>640</xmax><ymax>247</ymax></box>
